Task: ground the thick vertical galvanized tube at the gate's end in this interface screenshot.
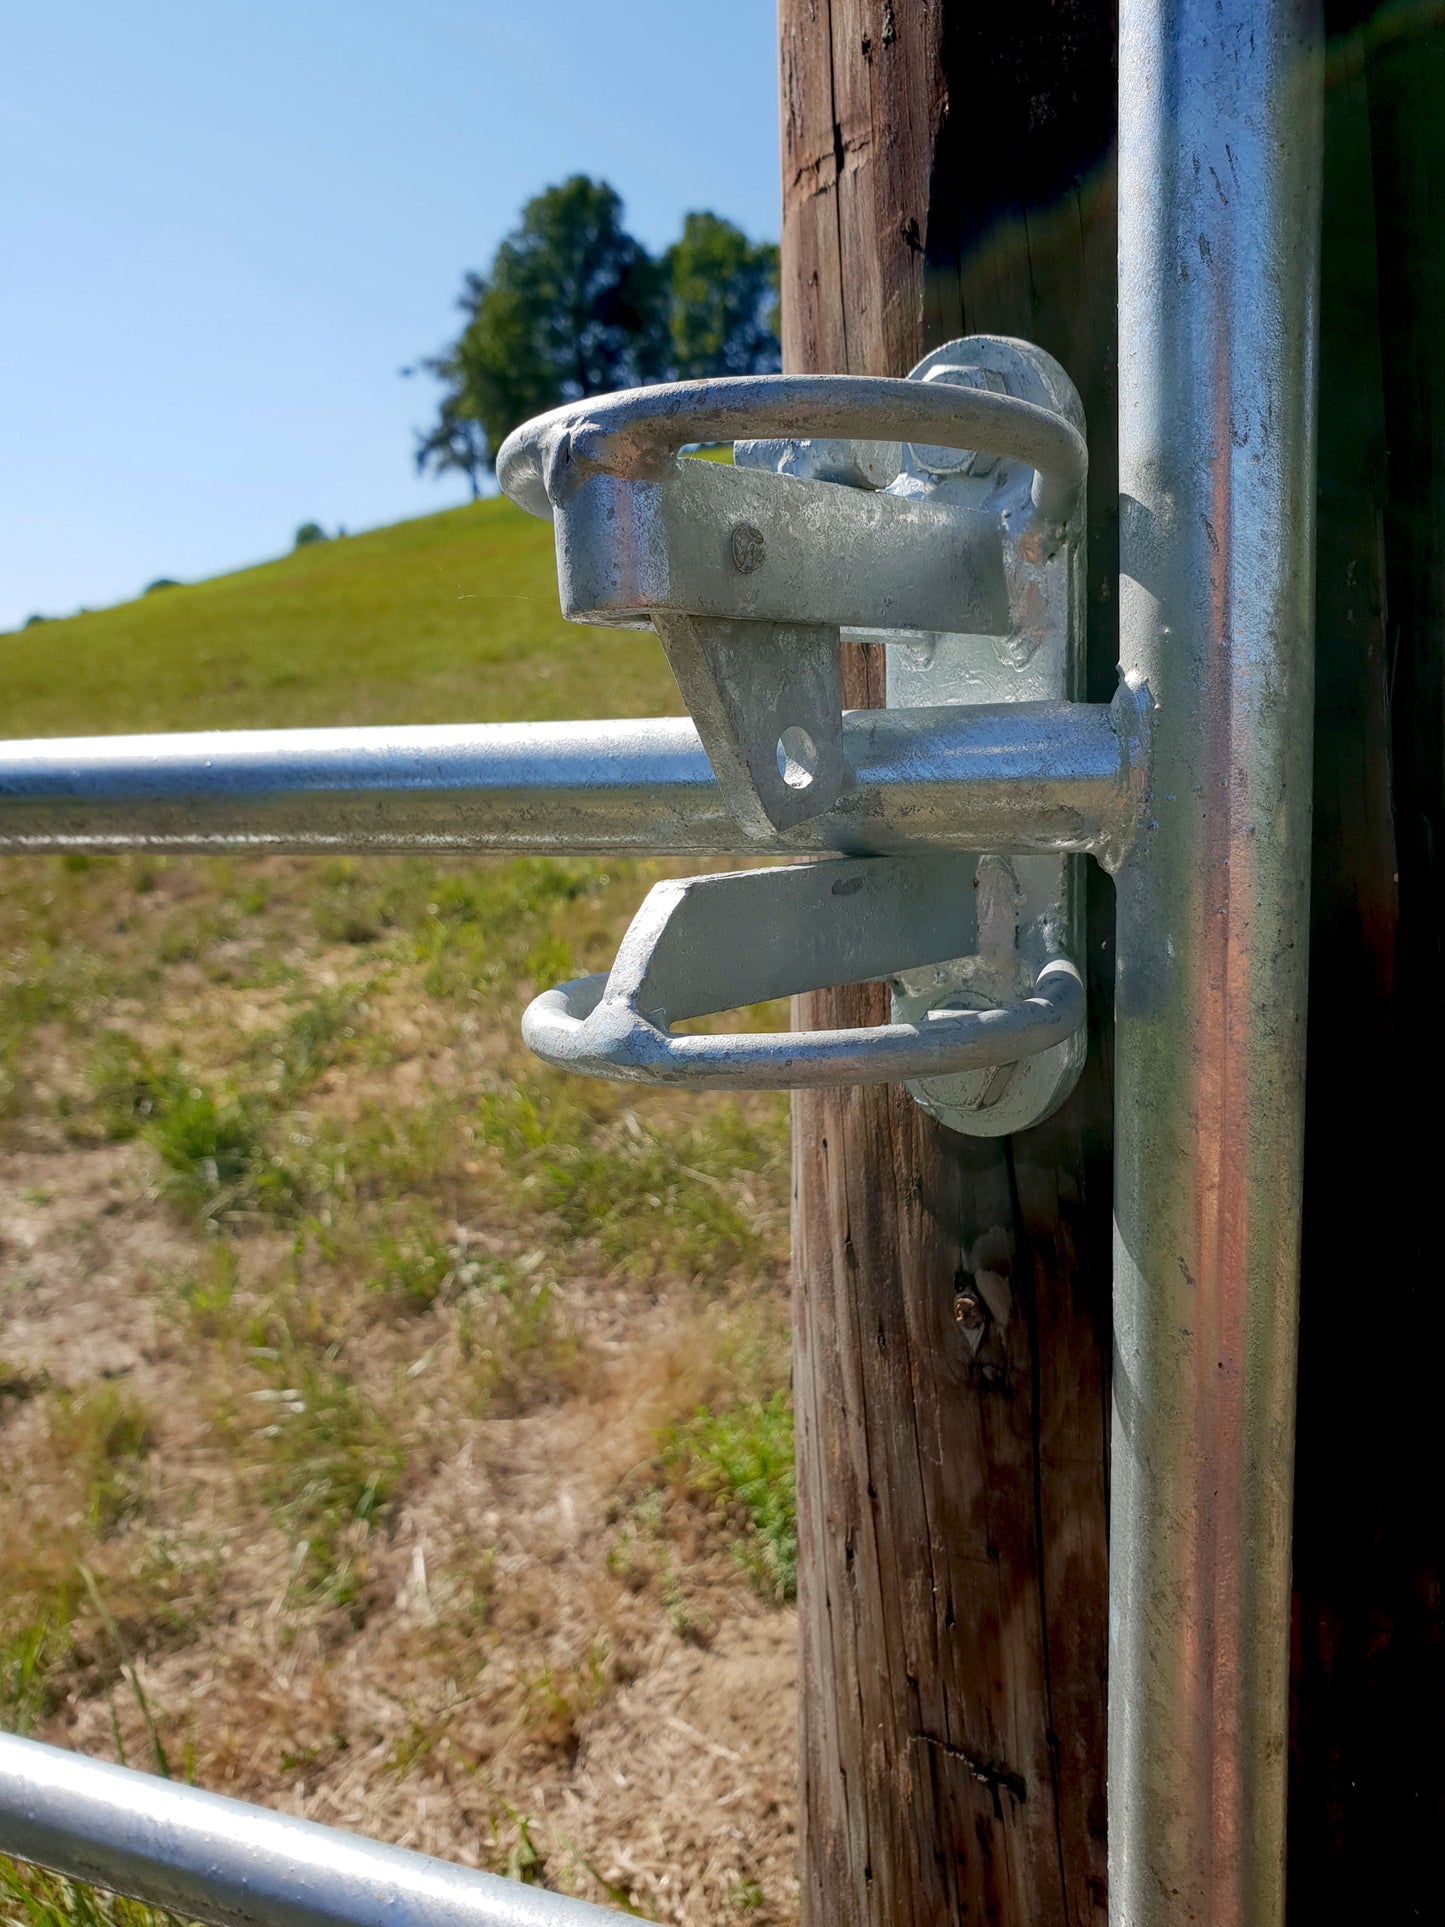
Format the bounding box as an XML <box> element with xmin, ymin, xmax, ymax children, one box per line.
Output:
<box><xmin>1110</xmin><ymin>0</ymin><xmax>1322</xmax><ymax>1927</ymax></box>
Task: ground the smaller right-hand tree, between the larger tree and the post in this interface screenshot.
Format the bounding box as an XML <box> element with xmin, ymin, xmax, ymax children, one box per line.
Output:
<box><xmin>663</xmin><ymin>214</ymin><xmax>782</xmax><ymax>382</ymax></box>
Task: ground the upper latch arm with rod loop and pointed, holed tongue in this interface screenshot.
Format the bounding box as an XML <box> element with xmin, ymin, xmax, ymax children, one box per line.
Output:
<box><xmin>497</xmin><ymin>364</ymin><xmax>1087</xmax><ymax>838</ymax></box>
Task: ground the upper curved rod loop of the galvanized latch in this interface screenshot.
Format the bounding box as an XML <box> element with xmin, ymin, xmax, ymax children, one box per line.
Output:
<box><xmin>497</xmin><ymin>374</ymin><xmax>1089</xmax><ymax>522</ymax></box>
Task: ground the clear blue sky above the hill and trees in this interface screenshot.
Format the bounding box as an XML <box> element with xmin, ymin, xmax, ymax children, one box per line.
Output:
<box><xmin>0</xmin><ymin>0</ymin><xmax>778</xmax><ymax>628</ymax></box>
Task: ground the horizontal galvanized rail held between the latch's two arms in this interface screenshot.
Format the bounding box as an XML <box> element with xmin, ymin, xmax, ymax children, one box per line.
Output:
<box><xmin>0</xmin><ymin>703</ymin><xmax>1141</xmax><ymax>858</ymax></box>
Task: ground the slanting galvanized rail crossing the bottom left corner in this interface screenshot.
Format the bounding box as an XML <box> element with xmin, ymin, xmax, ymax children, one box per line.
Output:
<box><xmin>0</xmin><ymin>1734</ymin><xmax>643</xmax><ymax>1927</ymax></box>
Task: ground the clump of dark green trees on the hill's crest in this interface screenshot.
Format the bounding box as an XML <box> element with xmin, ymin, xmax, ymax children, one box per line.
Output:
<box><xmin>416</xmin><ymin>173</ymin><xmax>778</xmax><ymax>493</ymax></box>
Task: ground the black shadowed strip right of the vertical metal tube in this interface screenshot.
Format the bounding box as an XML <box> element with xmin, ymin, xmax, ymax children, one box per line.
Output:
<box><xmin>1289</xmin><ymin>11</ymin><xmax>1445</xmax><ymax>1927</ymax></box>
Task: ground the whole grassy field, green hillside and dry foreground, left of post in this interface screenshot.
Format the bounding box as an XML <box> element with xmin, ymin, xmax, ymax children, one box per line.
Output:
<box><xmin>0</xmin><ymin>501</ymin><xmax>796</xmax><ymax>1927</ymax></box>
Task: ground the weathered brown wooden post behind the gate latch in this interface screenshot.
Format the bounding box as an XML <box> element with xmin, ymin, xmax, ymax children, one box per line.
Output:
<box><xmin>780</xmin><ymin>0</ymin><xmax>1117</xmax><ymax>1927</ymax></box>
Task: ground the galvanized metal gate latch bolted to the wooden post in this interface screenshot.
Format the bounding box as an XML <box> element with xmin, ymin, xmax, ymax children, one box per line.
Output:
<box><xmin>497</xmin><ymin>335</ymin><xmax>1146</xmax><ymax>1137</ymax></box>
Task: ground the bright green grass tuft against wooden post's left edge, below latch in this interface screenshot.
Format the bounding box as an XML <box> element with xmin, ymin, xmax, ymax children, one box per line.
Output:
<box><xmin>659</xmin><ymin>1391</ymin><xmax>798</xmax><ymax>1599</ymax></box>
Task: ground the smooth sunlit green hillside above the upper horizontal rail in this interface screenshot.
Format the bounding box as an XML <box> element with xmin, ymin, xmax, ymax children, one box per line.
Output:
<box><xmin>0</xmin><ymin>499</ymin><xmax>680</xmax><ymax>736</ymax></box>
